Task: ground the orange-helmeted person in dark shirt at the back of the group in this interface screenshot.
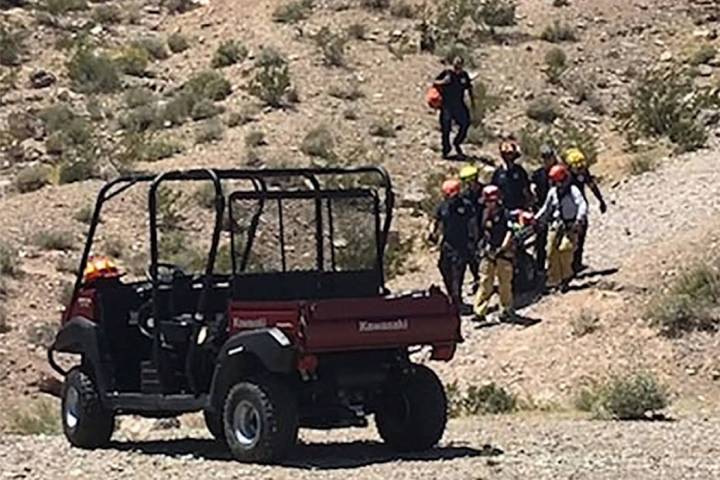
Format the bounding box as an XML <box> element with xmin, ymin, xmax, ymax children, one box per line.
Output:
<box><xmin>490</xmin><ymin>140</ymin><xmax>530</xmax><ymax>211</ymax></box>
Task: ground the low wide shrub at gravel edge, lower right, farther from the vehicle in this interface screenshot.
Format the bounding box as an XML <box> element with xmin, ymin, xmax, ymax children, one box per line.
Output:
<box><xmin>575</xmin><ymin>372</ymin><xmax>670</xmax><ymax>420</ymax></box>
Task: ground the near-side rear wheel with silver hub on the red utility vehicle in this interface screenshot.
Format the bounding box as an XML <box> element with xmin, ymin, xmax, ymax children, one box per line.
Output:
<box><xmin>223</xmin><ymin>377</ymin><xmax>298</xmax><ymax>463</ymax></box>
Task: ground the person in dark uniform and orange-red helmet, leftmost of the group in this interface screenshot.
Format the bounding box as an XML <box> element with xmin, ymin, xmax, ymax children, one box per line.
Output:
<box><xmin>430</xmin><ymin>179</ymin><xmax>477</xmax><ymax>306</ymax></box>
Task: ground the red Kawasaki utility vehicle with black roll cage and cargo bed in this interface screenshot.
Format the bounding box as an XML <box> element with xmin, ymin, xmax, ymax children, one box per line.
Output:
<box><xmin>48</xmin><ymin>167</ymin><xmax>460</xmax><ymax>462</ymax></box>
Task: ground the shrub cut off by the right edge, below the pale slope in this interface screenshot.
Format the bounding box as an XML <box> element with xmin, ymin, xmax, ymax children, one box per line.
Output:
<box><xmin>648</xmin><ymin>264</ymin><xmax>720</xmax><ymax>337</ymax></box>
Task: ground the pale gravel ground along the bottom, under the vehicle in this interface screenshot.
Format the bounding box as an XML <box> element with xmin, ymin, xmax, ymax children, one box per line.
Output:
<box><xmin>0</xmin><ymin>415</ymin><xmax>720</xmax><ymax>480</ymax></box>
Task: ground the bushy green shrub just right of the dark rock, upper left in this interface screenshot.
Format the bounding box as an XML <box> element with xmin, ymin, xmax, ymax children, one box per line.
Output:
<box><xmin>67</xmin><ymin>47</ymin><xmax>120</xmax><ymax>93</ymax></box>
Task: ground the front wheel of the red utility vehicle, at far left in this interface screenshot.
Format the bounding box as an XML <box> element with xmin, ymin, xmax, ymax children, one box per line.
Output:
<box><xmin>61</xmin><ymin>367</ymin><xmax>115</xmax><ymax>449</ymax></box>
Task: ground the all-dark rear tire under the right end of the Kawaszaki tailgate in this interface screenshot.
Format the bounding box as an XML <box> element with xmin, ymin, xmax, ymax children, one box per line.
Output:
<box><xmin>375</xmin><ymin>365</ymin><xmax>447</xmax><ymax>452</ymax></box>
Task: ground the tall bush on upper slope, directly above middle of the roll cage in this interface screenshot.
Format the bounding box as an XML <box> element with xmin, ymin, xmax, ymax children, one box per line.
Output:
<box><xmin>250</xmin><ymin>48</ymin><xmax>291</xmax><ymax>108</ymax></box>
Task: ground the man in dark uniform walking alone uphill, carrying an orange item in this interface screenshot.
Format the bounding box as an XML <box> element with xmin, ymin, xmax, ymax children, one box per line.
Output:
<box><xmin>433</xmin><ymin>57</ymin><xmax>475</xmax><ymax>159</ymax></box>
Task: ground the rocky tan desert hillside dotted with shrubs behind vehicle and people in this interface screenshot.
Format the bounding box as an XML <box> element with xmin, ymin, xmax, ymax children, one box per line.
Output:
<box><xmin>0</xmin><ymin>0</ymin><xmax>720</xmax><ymax>432</ymax></box>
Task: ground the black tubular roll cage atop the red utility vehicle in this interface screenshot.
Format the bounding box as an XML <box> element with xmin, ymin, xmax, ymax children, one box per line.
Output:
<box><xmin>68</xmin><ymin>166</ymin><xmax>395</xmax><ymax>315</ymax></box>
